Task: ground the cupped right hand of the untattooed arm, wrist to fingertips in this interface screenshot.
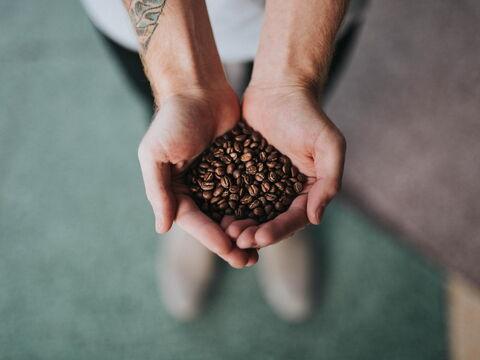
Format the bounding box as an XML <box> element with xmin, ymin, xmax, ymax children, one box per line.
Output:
<box><xmin>225</xmin><ymin>84</ymin><xmax>346</xmax><ymax>249</ymax></box>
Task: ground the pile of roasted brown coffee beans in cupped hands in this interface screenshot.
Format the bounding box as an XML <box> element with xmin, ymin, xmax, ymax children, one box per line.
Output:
<box><xmin>186</xmin><ymin>122</ymin><xmax>307</xmax><ymax>223</ymax></box>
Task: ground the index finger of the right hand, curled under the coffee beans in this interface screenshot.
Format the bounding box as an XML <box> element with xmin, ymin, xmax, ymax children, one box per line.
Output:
<box><xmin>254</xmin><ymin>195</ymin><xmax>308</xmax><ymax>248</ymax></box>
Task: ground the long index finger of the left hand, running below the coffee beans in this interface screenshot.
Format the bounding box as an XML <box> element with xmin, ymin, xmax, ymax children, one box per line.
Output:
<box><xmin>176</xmin><ymin>195</ymin><xmax>249</xmax><ymax>268</ymax></box>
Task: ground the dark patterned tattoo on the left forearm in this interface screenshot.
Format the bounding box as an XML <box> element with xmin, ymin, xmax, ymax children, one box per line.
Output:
<box><xmin>126</xmin><ymin>0</ymin><xmax>167</xmax><ymax>51</ymax></box>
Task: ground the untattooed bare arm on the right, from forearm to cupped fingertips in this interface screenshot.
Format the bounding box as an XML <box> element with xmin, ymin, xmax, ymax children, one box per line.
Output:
<box><xmin>230</xmin><ymin>0</ymin><xmax>346</xmax><ymax>249</ymax></box>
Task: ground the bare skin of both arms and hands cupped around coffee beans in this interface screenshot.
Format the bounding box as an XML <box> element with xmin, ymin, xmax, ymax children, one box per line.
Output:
<box><xmin>125</xmin><ymin>0</ymin><xmax>345</xmax><ymax>268</ymax></box>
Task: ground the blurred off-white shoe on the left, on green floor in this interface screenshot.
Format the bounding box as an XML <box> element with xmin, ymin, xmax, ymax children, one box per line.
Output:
<box><xmin>157</xmin><ymin>225</ymin><xmax>215</xmax><ymax>321</ymax></box>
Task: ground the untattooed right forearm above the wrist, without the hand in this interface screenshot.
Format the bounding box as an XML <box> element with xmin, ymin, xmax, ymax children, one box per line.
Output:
<box><xmin>251</xmin><ymin>0</ymin><xmax>348</xmax><ymax>87</ymax></box>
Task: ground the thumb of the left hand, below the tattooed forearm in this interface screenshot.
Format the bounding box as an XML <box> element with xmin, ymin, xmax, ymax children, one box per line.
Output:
<box><xmin>138</xmin><ymin>149</ymin><xmax>176</xmax><ymax>233</ymax></box>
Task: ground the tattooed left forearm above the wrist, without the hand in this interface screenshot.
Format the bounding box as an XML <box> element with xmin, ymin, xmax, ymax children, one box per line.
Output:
<box><xmin>124</xmin><ymin>0</ymin><xmax>226</xmax><ymax>101</ymax></box>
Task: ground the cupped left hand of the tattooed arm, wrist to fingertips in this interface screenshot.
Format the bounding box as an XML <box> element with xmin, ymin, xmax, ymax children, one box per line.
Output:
<box><xmin>138</xmin><ymin>86</ymin><xmax>258</xmax><ymax>268</ymax></box>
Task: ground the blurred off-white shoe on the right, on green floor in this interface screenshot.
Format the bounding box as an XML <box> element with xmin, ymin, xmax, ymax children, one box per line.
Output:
<box><xmin>257</xmin><ymin>231</ymin><xmax>313</xmax><ymax>322</ymax></box>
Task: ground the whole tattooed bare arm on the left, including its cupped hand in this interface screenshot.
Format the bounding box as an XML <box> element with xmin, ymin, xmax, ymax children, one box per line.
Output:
<box><xmin>125</xmin><ymin>0</ymin><xmax>258</xmax><ymax>268</ymax></box>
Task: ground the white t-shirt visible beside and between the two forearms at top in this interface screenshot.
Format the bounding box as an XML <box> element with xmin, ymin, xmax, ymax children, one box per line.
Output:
<box><xmin>81</xmin><ymin>0</ymin><xmax>265</xmax><ymax>62</ymax></box>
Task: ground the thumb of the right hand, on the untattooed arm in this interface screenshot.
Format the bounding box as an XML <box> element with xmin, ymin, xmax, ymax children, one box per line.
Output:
<box><xmin>307</xmin><ymin>132</ymin><xmax>345</xmax><ymax>224</ymax></box>
